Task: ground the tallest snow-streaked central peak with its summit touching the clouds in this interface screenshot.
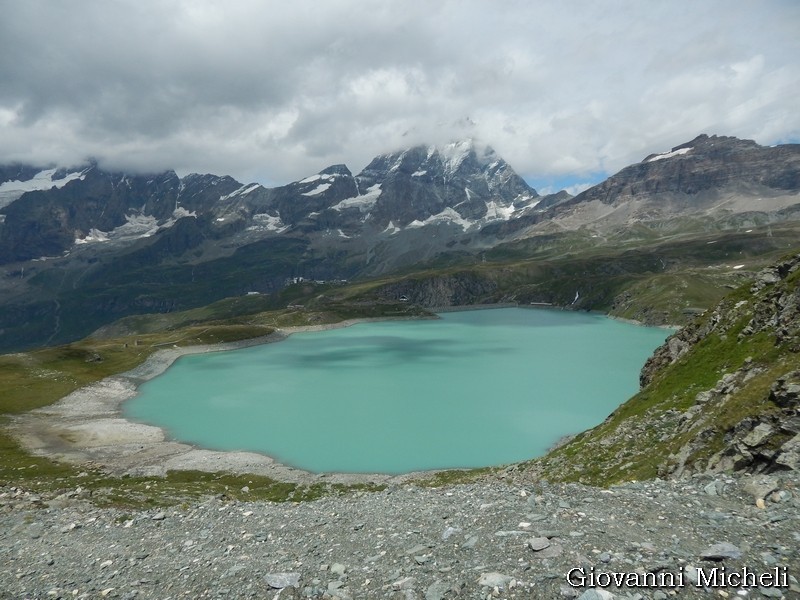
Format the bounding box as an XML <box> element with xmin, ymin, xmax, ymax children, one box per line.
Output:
<box><xmin>222</xmin><ymin>140</ymin><xmax>539</xmax><ymax>239</ymax></box>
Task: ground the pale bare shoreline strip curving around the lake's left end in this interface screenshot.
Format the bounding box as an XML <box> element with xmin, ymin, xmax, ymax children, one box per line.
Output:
<box><xmin>8</xmin><ymin>317</ymin><xmax>444</xmax><ymax>484</ymax></box>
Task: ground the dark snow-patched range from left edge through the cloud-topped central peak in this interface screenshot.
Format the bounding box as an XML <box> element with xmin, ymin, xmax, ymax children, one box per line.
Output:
<box><xmin>0</xmin><ymin>140</ymin><xmax>540</xmax><ymax>263</ymax></box>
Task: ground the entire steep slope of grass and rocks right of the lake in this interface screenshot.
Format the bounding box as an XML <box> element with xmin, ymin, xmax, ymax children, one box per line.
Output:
<box><xmin>540</xmin><ymin>254</ymin><xmax>800</xmax><ymax>482</ymax></box>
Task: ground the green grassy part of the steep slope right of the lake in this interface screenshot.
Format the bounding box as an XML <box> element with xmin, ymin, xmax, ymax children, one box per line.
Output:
<box><xmin>527</xmin><ymin>260</ymin><xmax>800</xmax><ymax>485</ymax></box>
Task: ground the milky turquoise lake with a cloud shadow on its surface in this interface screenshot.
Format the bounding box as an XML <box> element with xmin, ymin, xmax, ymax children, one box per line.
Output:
<box><xmin>123</xmin><ymin>308</ymin><xmax>669</xmax><ymax>474</ymax></box>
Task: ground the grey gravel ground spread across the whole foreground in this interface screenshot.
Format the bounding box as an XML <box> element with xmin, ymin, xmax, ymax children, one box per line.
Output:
<box><xmin>0</xmin><ymin>473</ymin><xmax>800</xmax><ymax>600</ymax></box>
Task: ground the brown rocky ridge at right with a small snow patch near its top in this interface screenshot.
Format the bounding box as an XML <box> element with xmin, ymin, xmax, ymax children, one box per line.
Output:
<box><xmin>500</xmin><ymin>134</ymin><xmax>800</xmax><ymax>236</ymax></box>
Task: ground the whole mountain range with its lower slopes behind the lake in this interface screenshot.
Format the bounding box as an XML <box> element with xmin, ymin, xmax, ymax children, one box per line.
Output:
<box><xmin>0</xmin><ymin>135</ymin><xmax>800</xmax><ymax>351</ymax></box>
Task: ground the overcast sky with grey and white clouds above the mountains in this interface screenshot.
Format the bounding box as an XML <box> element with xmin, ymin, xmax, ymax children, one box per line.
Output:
<box><xmin>0</xmin><ymin>0</ymin><xmax>800</xmax><ymax>191</ymax></box>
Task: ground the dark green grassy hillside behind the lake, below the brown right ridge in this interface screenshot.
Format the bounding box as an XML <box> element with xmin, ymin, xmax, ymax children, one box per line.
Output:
<box><xmin>331</xmin><ymin>228</ymin><xmax>797</xmax><ymax>325</ymax></box>
